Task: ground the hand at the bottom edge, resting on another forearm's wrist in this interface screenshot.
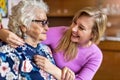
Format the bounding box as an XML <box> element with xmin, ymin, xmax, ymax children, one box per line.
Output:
<box><xmin>62</xmin><ymin>67</ymin><xmax>75</xmax><ymax>80</ymax></box>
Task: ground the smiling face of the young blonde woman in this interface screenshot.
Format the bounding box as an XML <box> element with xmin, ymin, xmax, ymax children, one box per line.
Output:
<box><xmin>71</xmin><ymin>16</ymin><xmax>94</xmax><ymax>46</ymax></box>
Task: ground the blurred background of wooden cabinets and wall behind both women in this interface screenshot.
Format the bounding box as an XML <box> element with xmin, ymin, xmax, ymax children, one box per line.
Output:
<box><xmin>0</xmin><ymin>0</ymin><xmax>120</xmax><ymax>80</ymax></box>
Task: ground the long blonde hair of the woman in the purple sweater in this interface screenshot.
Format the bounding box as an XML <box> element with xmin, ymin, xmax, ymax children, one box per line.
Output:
<box><xmin>55</xmin><ymin>7</ymin><xmax>107</xmax><ymax>61</ymax></box>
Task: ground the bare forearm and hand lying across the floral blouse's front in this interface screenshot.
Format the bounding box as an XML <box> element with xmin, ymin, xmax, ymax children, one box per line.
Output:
<box><xmin>34</xmin><ymin>55</ymin><xmax>62</xmax><ymax>80</ymax></box>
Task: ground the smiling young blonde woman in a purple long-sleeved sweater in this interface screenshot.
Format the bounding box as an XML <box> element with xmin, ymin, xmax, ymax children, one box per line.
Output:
<box><xmin>0</xmin><ymin>7</ymin><xmax>107</xmax><ymax>80</ymax></box>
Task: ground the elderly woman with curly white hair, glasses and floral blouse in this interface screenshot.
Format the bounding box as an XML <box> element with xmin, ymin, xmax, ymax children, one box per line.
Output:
<box><xmin>0</xmin><ymin>0</ymin><xmax>62</xmax><ymax>80</ymax></box>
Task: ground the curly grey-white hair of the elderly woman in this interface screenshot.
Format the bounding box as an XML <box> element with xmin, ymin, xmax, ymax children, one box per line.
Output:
<box><xmin>8</xmin><ymin>0</ymin><xmax>48</xmax><ymax>37</ymax></box>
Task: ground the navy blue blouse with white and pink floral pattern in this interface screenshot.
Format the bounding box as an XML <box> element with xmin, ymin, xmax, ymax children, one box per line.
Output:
<box><xmin>0</xmin><ymin>42</ymin><xmax>55</xmax><ymax>80</ymax></box>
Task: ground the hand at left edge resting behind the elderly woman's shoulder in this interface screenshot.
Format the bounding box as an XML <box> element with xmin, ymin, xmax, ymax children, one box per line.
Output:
<box><xmin>0</xmin><ymin>29</ymin><xmax>24</xmax><ymax>48</ymax></box>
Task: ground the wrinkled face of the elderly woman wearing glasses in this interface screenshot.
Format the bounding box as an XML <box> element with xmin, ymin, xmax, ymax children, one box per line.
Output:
<box><xmin>27</xmin><ymin>9</ymin><xmax>48</xmax><ymax>41</ymax></box>
